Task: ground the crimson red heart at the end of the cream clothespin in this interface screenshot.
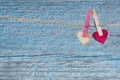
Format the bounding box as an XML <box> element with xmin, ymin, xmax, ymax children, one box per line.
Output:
<box><xmin>93</xmin><ymin>30</ymin><xmax>108</xmax><ymax>44</ymax></box>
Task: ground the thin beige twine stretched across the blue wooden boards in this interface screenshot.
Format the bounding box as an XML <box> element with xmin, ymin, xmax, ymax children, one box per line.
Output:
<box><xmin>0</xmin><ymin>16</ymin><xmax>120</xmax><ymax>27</ymax></box>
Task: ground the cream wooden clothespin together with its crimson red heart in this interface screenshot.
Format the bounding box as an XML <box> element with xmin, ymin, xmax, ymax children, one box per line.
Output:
<box><xmin>92</xmin><ymin>10</ymin><xmax>108</xmax><ymax>44</ymax></box>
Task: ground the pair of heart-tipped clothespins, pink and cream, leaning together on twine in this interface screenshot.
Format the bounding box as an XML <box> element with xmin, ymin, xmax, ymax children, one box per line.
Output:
<box><xmin>77</xmin><ymin>10</ymin><xmax>108</xmax><ymax>44</ymax></box>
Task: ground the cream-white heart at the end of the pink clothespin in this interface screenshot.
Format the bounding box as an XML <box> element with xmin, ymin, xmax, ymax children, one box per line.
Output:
<box><xmin>77</xmin><ymin>31</ymin><xmax>92</xmax><ymax>44</ymax></box>
